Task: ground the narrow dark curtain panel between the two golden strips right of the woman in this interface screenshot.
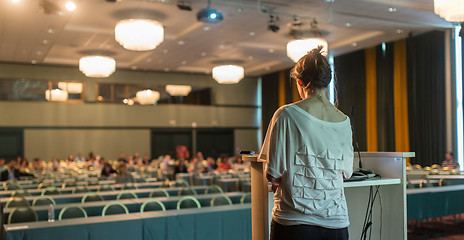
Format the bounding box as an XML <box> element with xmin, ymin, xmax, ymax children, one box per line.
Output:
<box><xmin>376</xmin><ymin>43</ymin><xmax>396</xmax><ymax>152</ymax></box>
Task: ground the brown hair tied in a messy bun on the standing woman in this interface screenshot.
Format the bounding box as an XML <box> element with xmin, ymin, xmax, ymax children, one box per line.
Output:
<box><xmin>290</xmin><ymin>46</ymin><xmax>332</xmax><ymax>90</ymax></box>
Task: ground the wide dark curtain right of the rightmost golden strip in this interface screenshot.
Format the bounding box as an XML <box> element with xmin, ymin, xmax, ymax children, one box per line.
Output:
<box><xmin>407</xmin><ymin>31</ymin><xmax>446</xmax><ymax>166</ymax></box>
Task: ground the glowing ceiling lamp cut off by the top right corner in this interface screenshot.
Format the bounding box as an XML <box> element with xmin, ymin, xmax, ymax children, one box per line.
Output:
<box><xmin>434</xmin><ymin>0</ymin><xmax>464</xmax><ymax>22</ymax></box>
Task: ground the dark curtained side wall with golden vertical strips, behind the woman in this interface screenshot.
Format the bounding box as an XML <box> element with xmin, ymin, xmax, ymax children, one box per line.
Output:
<box><xmin>262</xmin><ymin>31</ymin><xmax>446</xmax><ymax>165</ymax></box>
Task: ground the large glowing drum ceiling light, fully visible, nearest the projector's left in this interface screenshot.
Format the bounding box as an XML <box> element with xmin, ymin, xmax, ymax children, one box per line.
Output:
<box><xmin>114</xmin><ymin>19</ymin><xmax>164</xmax><ymax>51</ymax></box>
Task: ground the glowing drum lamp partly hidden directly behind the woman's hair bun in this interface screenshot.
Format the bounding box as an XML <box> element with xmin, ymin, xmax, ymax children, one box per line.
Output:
<box><xmin>287</xmin><ymin>38</ymin><xmax>328</xmax><ymax>62</ymax></box>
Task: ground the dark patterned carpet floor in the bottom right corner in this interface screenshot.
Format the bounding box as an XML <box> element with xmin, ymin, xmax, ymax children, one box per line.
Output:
<box><xmin>408</xmin><ymin>215</ymin><xmax>464</xmax><ymax>240</ymax></box>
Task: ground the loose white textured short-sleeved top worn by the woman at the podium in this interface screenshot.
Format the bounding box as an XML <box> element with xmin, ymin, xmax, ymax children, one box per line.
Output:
<box><xmin>258</xmin><ymin>104</ymin><xmax>353</xmax><ymax>229</ymax></box>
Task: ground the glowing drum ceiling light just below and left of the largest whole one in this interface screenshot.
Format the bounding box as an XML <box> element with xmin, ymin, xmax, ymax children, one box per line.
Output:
<box><xmin>79</xmin><ymin>56</ymin><xmax>116</xmax><ymax>77</ymax></box>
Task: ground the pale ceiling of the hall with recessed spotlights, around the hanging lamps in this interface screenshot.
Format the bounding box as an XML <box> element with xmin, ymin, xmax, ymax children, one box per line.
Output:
<box><xmin>0</xmin><ymin>0</ymin><xmax>452</xmax><ymax>76</ymax></box>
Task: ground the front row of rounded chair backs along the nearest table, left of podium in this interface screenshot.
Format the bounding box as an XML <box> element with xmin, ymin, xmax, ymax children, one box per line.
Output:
<box><xmin>8</xmin><ymin>193</ymin><xmax>251</xmax><ymax>224</ymax></box>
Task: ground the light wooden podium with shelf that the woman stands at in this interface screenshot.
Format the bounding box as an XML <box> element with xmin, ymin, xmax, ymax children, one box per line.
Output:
<box><xmin>242</xmin><ymin>152</ymin><xmax>415</xmax><ymax>240</ymax></box>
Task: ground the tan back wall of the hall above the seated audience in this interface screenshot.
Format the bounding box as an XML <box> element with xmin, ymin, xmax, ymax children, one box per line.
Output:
<box><xmin>0</xmin><ymin>63</ymin><xmax>261</xmax><ymax>160</ymax></box>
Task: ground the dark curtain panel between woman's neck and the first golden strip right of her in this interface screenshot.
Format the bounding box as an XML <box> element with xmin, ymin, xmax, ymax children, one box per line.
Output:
<box><xmin>334</xmin><ymin>50</ymin><xmax>367</xmax><ymax>151</ymax></box>
